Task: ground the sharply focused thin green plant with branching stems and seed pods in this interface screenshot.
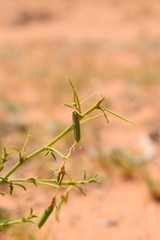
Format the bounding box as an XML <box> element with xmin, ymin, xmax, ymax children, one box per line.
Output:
<box><xmin>0</xmin><ymin>81</ymin><xmax>135</xmax><ymax>228</ymax></box>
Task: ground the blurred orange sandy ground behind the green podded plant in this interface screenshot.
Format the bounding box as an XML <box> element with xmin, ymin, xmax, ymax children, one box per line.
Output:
<box><xmin>0</xmin><ymin>0</ymin><xmax>160</xmax><ymax>240</ymax></box>
